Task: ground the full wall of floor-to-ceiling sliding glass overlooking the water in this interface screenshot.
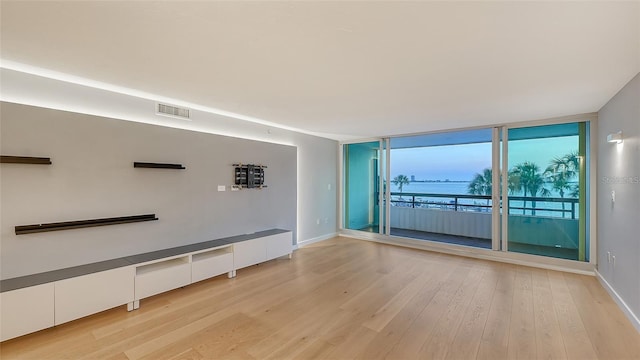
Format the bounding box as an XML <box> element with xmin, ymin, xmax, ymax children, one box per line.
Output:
<box><xmin>342</xmin><ymin>122</ymin><xmax>590</xmax><ymax>261</ymax></box>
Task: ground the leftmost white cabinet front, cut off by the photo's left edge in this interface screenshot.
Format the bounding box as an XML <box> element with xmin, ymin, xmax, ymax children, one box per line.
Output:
<box><xmin>0</xmin><ymin>283</ymin><xmax>54</xmax><ymax>341</ymax></box>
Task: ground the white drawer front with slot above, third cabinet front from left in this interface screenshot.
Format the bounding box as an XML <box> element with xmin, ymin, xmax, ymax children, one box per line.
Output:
<box><xmin>135</xmin><ymin>256</ymin><xmax>191</xmax><ymax>300</ymax></box>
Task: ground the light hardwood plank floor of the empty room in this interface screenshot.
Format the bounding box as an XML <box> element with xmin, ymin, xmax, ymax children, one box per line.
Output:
<box><xmin>0</xmin><ymin>238</ymin><xmax>640</xmax><ymax>360</ymax></box>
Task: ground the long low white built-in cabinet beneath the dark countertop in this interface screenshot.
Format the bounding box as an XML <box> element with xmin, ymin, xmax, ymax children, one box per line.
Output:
<box><xmin>0</xmin><ymin>230</ymin><xmax>293</xmax><ymax>341</ymax></box>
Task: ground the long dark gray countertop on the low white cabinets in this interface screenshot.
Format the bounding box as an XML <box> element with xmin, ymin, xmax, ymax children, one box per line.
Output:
<box><xmin>0</xmin><ymin>229</ymin><xmax>290</xmax><ymax>292</ymax></box>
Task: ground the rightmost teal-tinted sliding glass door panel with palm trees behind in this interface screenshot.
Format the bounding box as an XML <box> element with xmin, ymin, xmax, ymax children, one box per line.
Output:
<box><xmin>503</xmin><ymin>122</ymin><xmax>588</xmax><ymax>261</ymax></box>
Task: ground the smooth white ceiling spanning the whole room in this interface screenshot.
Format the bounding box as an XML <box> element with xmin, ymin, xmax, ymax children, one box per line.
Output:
<box><xmin>1</xmin><ymin>1</ymin><xmax>640</xmax><ymax>139</ymax></box>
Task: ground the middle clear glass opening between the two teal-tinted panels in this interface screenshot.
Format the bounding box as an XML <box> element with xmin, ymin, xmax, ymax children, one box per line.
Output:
<box><xmin>389</xmin><ymin>129</ymin><xmax>493</xmax><ymax>249</ymax></box>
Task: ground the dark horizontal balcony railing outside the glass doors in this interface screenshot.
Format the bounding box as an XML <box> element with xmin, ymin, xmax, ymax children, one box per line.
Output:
<box><xmin>391</xmin><ymin>192</ymin><xmax>578</xmax><ymax>219</ymax></box>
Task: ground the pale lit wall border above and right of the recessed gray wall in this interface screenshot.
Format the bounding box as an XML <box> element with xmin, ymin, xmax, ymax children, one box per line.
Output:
<box><xmin>0</xmin><ymin>68</ymin><xmax>338</xmax><ymax>258</ymax></box>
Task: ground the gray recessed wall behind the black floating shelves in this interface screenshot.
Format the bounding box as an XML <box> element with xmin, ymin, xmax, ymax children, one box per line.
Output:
<box><xmin>0</xmin><ymin>103</ymin><xmax>302</xmax><ymax>278</ymax></box>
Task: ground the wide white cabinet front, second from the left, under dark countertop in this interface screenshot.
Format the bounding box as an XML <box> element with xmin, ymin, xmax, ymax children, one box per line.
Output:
<box><xmin>55</xmin><ymin>266</ymin><xmax>135</xmax><ymax>325</ymax></box>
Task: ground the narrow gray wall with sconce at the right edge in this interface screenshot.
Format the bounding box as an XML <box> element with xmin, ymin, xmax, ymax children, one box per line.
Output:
<box><xmin>597</xmin><ymin>74</ymin><xmax>640</xmax><ymax>317</ymax></box>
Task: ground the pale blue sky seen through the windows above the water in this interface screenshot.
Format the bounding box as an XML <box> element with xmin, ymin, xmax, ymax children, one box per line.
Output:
<box><xmin>391</xmin><ymin>136</ymin><xmax>578</xmax><ymax>181</ymax></box>
